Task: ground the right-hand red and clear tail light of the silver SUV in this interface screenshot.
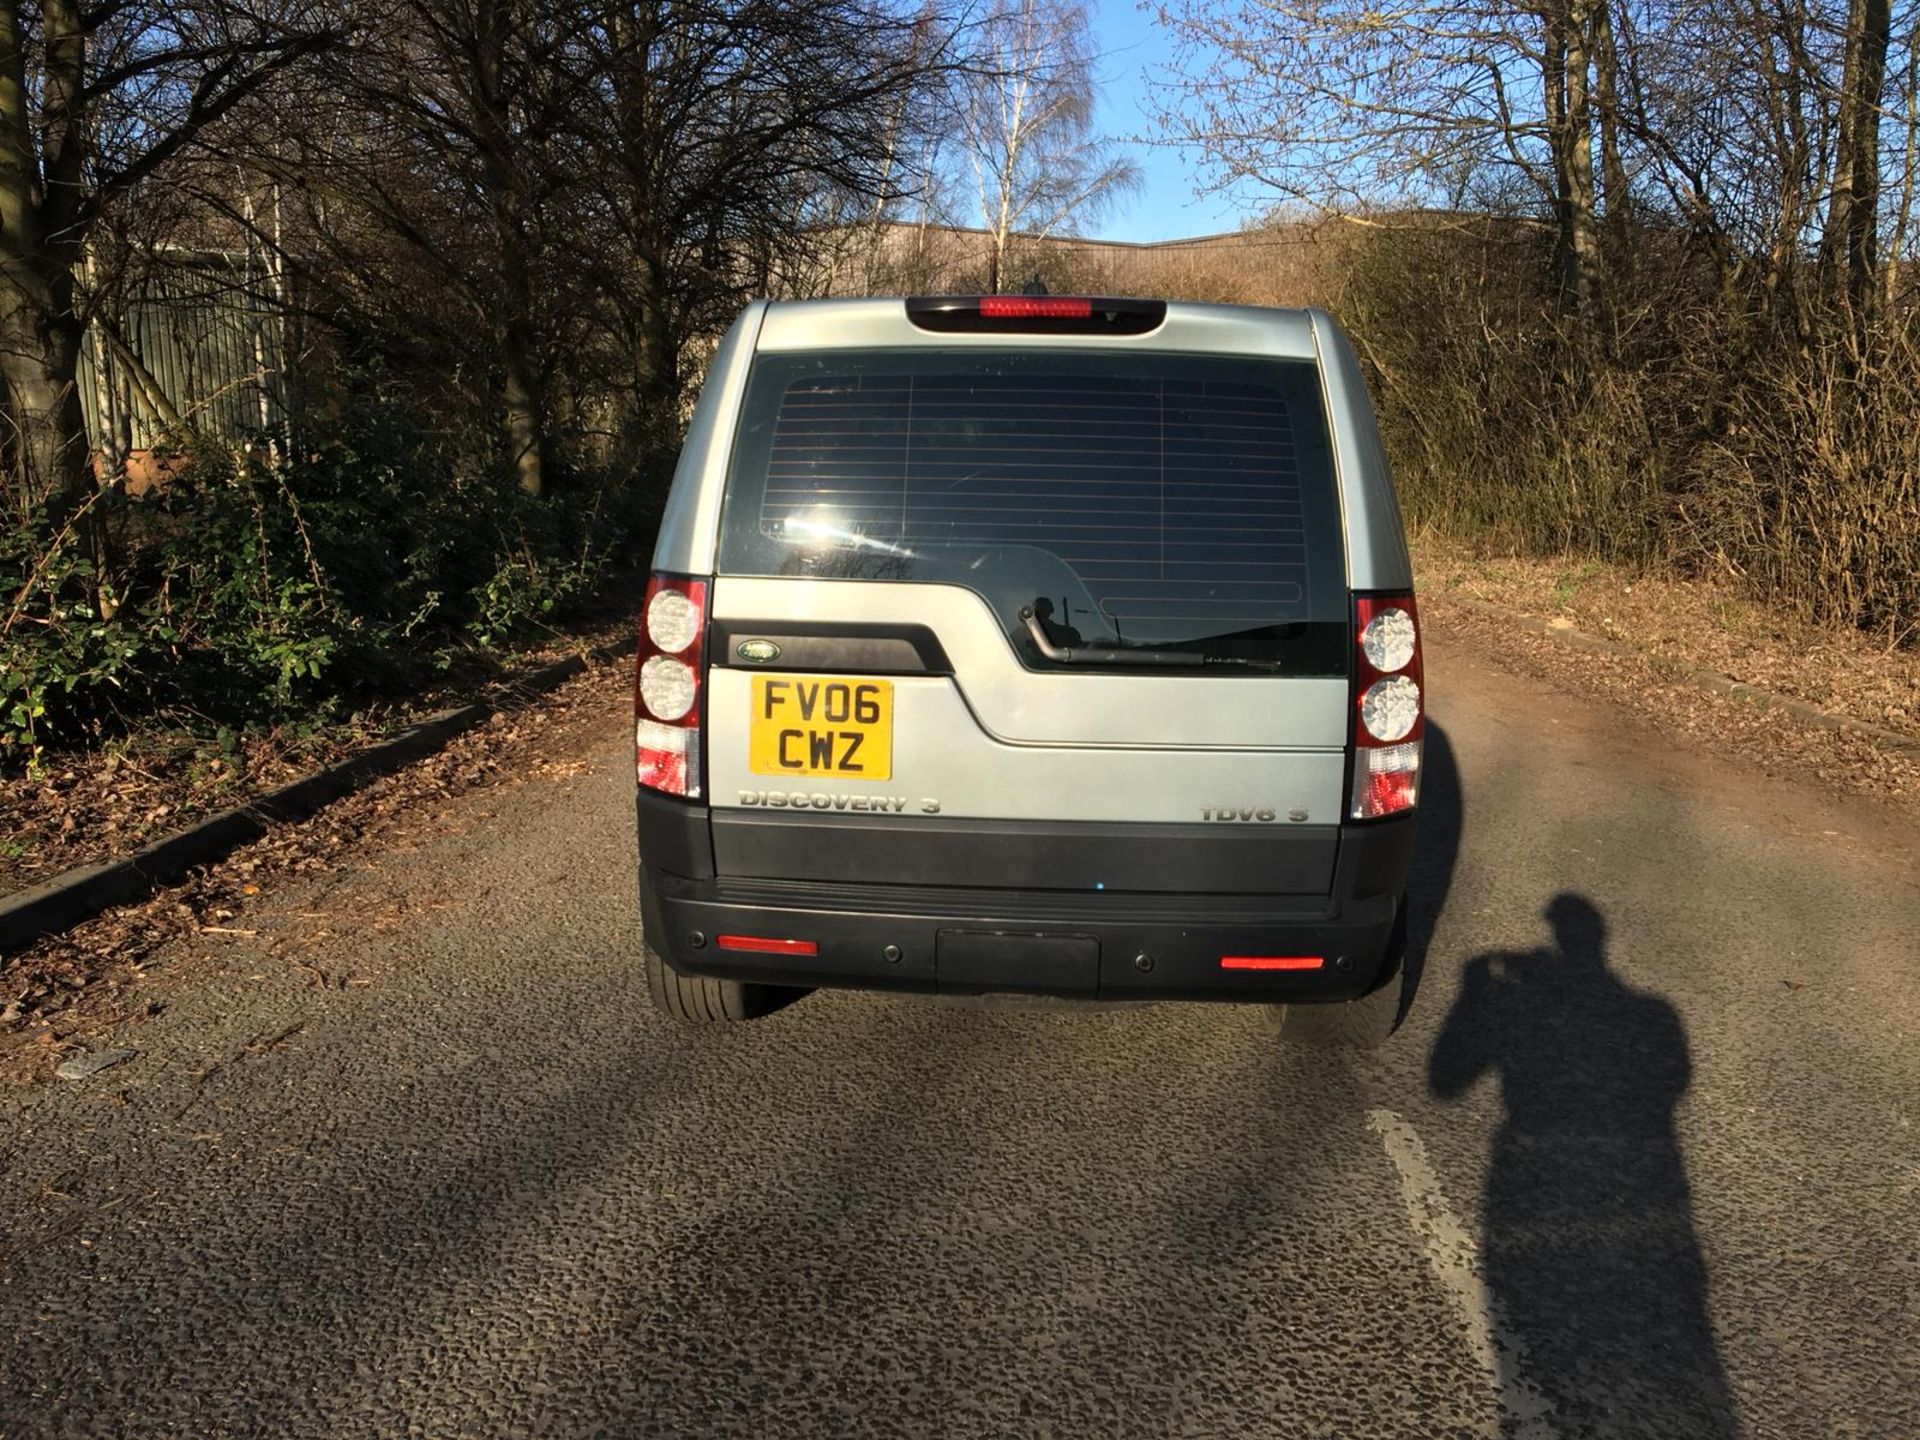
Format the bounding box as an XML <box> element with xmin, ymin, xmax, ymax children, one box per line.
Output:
<box><xmin>1350</xmin><ymin>595</ymin><xmax>1427</xmax><ymax>820</ymax></box>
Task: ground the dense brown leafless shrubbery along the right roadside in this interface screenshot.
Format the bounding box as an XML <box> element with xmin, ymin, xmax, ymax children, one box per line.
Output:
<box><xmin>1329</xmin><ymin>221</ymin><xmax>1920</xmax><ymax>643</ymax></box>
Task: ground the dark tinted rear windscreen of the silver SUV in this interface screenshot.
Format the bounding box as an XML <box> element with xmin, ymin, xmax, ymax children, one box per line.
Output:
<box><xmin>720</xmin><ymin>349</ymin><xmax>1348</xmax><ymax>674</ymax></box>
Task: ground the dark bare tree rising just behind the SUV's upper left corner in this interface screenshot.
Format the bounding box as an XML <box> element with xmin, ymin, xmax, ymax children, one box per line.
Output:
<box><xmin>574</xmin><ymin>0</ymin><xmax>958</xmax><ymax>464</ymax></box>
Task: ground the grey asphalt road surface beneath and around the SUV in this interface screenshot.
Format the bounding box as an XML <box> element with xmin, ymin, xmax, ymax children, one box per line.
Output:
<box><xmin>0</xmin><ymin>634</ymin><xmax>1920</xmax><ymax>1440</ymax></box>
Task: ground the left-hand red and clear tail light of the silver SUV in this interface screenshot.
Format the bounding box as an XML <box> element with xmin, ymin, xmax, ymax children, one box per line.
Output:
<box><xmin>634</xmin><ymin>574</ymin><xmax>707</xmax><ymax>801</ymax></box>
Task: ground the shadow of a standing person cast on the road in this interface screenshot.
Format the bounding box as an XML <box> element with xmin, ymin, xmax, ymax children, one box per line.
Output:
<box><xmin>1428</xmin><ymin>895</ymin><xmax>1741</xmax><ymax>1440</ymax></box>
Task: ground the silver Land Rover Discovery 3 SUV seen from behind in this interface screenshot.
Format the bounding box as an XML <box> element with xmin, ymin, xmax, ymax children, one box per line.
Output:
<box><xmin>636</xmin><ymin>296</ymin><xmax>1425</xmax><ymax>1039</ymax></box>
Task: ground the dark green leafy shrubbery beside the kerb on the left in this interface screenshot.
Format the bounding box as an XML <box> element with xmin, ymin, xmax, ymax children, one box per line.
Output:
<box><xmin>0</xmin><ymin>380</ymin><xmax>641</xmax><ymax>768</ymax></box>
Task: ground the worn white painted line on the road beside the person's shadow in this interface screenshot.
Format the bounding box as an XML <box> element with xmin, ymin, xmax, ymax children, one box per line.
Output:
<box><xmin>1367</xmin><ymin>1110</ymin><xmax>1555</xmax><ymax>1440</ymax></box>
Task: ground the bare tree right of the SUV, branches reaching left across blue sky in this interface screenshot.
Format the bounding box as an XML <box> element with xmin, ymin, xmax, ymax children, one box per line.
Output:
<box><xmin>1160</xmin><ymin>0</ymin><xmax>1628</xmax><ymax>323</ymax></box>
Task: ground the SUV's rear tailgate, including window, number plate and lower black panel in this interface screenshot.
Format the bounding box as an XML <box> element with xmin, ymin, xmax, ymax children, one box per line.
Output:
<box><xmin>707</xmin><ymin>349</ymin><xmax>1350</xmax><ymax>895</ymax></box>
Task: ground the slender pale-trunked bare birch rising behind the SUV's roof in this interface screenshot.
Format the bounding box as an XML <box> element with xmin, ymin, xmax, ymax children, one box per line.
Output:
<box><xmin>958</xmin><ymin>0</ymin><xmax>1140</xmax><ymax>290</ymax></box>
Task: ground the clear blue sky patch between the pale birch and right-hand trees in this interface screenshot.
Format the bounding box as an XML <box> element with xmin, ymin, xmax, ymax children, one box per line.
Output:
<box><xmin>1087</xmin><ymin>0</ymin><xmax>1246</xmax><ymax>240</ymax></box>
